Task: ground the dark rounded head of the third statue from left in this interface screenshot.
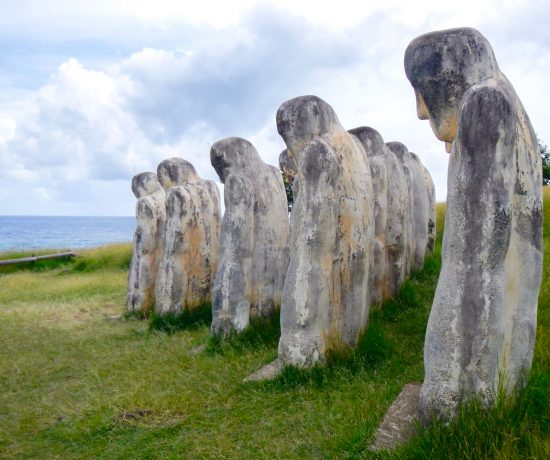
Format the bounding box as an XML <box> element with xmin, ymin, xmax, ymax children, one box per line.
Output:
<box><xmin>210</xmin><ymin>137</ymin><xmax>261</xmax><ymax>183</ymax></box>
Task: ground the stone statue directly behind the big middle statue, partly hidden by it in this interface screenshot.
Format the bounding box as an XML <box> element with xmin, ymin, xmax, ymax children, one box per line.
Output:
<box><xmin>349</xmin><ymin>126</ymin><xmax>412</xmax><ymax>302</ymax></box>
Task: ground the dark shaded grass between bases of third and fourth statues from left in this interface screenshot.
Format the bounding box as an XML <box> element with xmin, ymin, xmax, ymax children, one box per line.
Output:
<box><xmin>206</xmin><ymin>309</ymin><xmax>281</xmax><ymax>354</ymax></box>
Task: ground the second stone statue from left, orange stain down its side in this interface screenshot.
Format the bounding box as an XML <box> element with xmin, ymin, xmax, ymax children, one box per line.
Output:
<box><xmin>155</xmin><ymin>158</ymin><xmax>221</xmax><ymax>315</ymax></box>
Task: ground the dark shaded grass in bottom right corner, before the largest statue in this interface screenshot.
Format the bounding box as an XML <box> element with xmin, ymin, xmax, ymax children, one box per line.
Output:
<box><xmin>393</xmin><ymin>369</ymin><xmax>550</xmax><ymax>459</ymax></box>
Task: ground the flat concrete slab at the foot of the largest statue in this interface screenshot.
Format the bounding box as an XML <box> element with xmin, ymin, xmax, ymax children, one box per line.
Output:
<box><xmin>370</xmin><ymin>383</ymin><xmax>422</xmax><ymax>451</ymax></box>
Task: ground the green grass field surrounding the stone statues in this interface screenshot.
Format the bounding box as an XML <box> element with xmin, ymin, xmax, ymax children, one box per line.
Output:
<box><xmin>0</xmin><ymin>188</ymin><xmax>550</xmax><ymax>459</ymax></box>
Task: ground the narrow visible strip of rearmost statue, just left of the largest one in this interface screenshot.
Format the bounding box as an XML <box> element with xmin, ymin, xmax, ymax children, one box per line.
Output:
<box><xmin>386</xmin><ymin>142</ymin><xmax>430</xmax><ymax>270</ymax></box>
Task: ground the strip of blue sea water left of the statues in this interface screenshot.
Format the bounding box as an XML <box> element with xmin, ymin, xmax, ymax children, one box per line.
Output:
<box><xmin>0</xmin><ymin>216</ymin><xmax>136</xmax><ymax>251</ymax></box>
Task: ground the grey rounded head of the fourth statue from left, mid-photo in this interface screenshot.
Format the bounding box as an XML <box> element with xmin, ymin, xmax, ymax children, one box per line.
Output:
<box><xmin>277</xmin><ymin>96</ymin><xmax>343</xmax><ymax>158</ymax></box>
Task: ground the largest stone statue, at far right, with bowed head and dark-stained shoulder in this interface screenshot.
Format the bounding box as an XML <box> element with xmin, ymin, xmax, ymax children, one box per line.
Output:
<box><xmin>405</xmin><ymin>28</ymin><xmax>542</xmax><ymax>420</ymax></box>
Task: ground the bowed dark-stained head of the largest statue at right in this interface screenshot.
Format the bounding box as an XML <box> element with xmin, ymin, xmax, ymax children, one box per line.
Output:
<box><xmin>405</xmin><ymin>28</ymin><xmax>500</xmax><ymax>145</ymax></box>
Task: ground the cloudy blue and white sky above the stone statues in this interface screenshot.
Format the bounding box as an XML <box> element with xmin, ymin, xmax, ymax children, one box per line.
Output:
<box><xmin>0</xmin><ymin>0</ymin><xmax>550</xmax><ymax>216</ymax></box>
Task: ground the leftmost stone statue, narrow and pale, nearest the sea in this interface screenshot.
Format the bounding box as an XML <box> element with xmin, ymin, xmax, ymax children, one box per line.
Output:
<box><xmin>127</xmin><ymin>172</ymin><xmax>166</xmax><ymax>313</ymax></box>
